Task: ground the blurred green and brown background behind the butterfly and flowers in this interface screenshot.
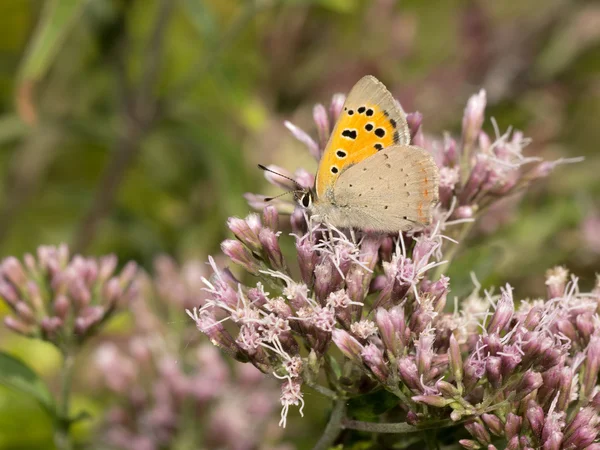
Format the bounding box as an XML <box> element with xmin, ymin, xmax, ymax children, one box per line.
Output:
<box><xmin>0</xmin><ymin>0</ymin><xmax>600</xmax><ymax>448</ymax></box>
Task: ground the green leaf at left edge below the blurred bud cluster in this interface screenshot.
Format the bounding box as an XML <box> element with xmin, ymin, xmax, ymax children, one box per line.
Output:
<box><xmin>0</xmin><ymin>352</ymin><xmax>56</xmax><ymax>416</ymax></box>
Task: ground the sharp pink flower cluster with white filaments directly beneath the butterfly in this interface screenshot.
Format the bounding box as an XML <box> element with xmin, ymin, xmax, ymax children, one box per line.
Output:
<box><xmin>188</xmin><ymin>202</ymin><xmax>448</xmax><ymax>426</ymax></box>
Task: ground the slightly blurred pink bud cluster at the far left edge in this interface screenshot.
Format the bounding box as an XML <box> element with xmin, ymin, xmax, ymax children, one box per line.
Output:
<box><xmin>0</xmin><ymin>245</ymin><xmax>137</xmax><ymax>350</ymax></box>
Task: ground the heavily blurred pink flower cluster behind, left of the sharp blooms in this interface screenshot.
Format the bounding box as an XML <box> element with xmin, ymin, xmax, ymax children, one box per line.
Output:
<box><xmin>95</xmin><ymin>256</ymin><xmax>286</xmax><ymax>450</ymax></box>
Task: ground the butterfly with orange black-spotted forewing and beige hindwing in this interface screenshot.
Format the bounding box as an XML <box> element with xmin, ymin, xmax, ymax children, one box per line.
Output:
<box><xmin>264</xmin><ymin>75</ymin><xmax>439</xmax><ymax>233</ymax></box>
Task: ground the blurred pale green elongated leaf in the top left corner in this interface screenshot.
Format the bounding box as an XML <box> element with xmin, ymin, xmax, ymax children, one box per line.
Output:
<box><xmin>20</xmin><ymin>0</ymin><xmax>85</xmax><ymax>81</ymax></box>
